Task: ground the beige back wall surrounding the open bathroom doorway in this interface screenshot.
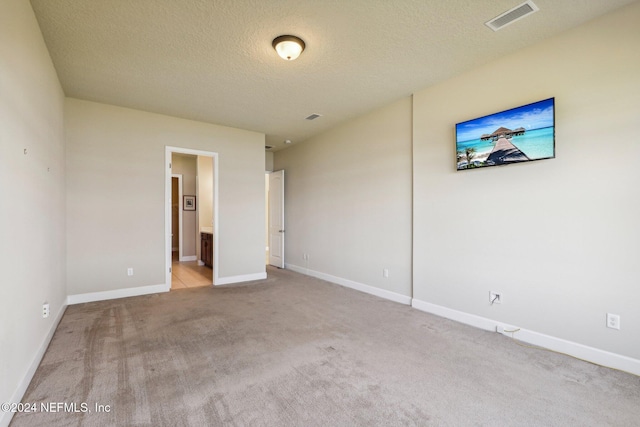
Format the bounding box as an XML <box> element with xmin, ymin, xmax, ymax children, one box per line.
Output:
<box><xmin>65</xmin><ymin>98</ymin><xmax>265</xmax><ymax>295</ymax></box>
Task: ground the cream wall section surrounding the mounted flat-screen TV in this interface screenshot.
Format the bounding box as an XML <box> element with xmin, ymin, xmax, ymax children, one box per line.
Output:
<box><xmin>413</xmin><ymin>3</ymin><xmax>640</xmax><ymax>359</ymax></box>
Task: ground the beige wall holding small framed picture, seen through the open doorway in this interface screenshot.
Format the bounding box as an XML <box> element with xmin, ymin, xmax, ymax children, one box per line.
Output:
<box><xmin>171</xmin><ymin>153</ymin><xmax>198</xmax><ymax>257</ymax></box>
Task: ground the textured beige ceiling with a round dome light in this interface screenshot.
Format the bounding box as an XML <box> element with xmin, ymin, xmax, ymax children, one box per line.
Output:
<box><xmin>31</xmin><ymin>0</ymin><xmax>631</xmax><ymax>150</ymax></box>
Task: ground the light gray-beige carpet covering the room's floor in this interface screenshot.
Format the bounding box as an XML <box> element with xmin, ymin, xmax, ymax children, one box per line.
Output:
<box><xmin>12</xmin><ymin>269</ymin><xmax>640</xmax><ymax>427</ymax></box>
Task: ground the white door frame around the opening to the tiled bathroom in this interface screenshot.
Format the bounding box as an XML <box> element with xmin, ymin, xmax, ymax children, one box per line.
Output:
<box><xmin>164</xmin><ymin>145</ymin><xmax>220</xmax><ymax>291</ymax></box>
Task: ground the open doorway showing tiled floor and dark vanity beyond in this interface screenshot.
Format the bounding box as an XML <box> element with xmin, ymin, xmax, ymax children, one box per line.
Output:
<box><xmin>165</xmin><ymin>147</ymin><xmax>218</xmax><ymax>290</ymax></box>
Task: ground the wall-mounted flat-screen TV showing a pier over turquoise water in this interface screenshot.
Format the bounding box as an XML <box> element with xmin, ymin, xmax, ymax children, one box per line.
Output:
<box><xmin>456</xmin><ymin>98</ymin><xmax>556</xmax><ymax>170</ymax></box>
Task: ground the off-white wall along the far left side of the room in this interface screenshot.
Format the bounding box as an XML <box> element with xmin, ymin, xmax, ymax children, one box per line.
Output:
<box><xmin>0</xmin><ymin>0</ymin><xmax>66</xmax><ymax>426</ymax></box>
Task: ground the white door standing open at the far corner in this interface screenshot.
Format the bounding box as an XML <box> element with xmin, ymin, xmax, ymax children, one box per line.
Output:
<box><xmin>269</xmin><ymin>170</ymin><xmax>284</xmax><ymax>268</ymax></box>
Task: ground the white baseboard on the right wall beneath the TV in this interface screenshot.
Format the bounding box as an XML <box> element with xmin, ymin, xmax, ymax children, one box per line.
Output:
<box><xmin>411</xmin><ymin>299</ymin><xmax>640</xmax><ymax>375</ymax></box>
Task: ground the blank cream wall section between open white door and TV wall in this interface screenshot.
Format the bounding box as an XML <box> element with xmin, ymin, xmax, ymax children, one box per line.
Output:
<box><xmin>274</xmin><ymin>98</ymin><xmax>411</xmax><ymax>297</ymax></box>
